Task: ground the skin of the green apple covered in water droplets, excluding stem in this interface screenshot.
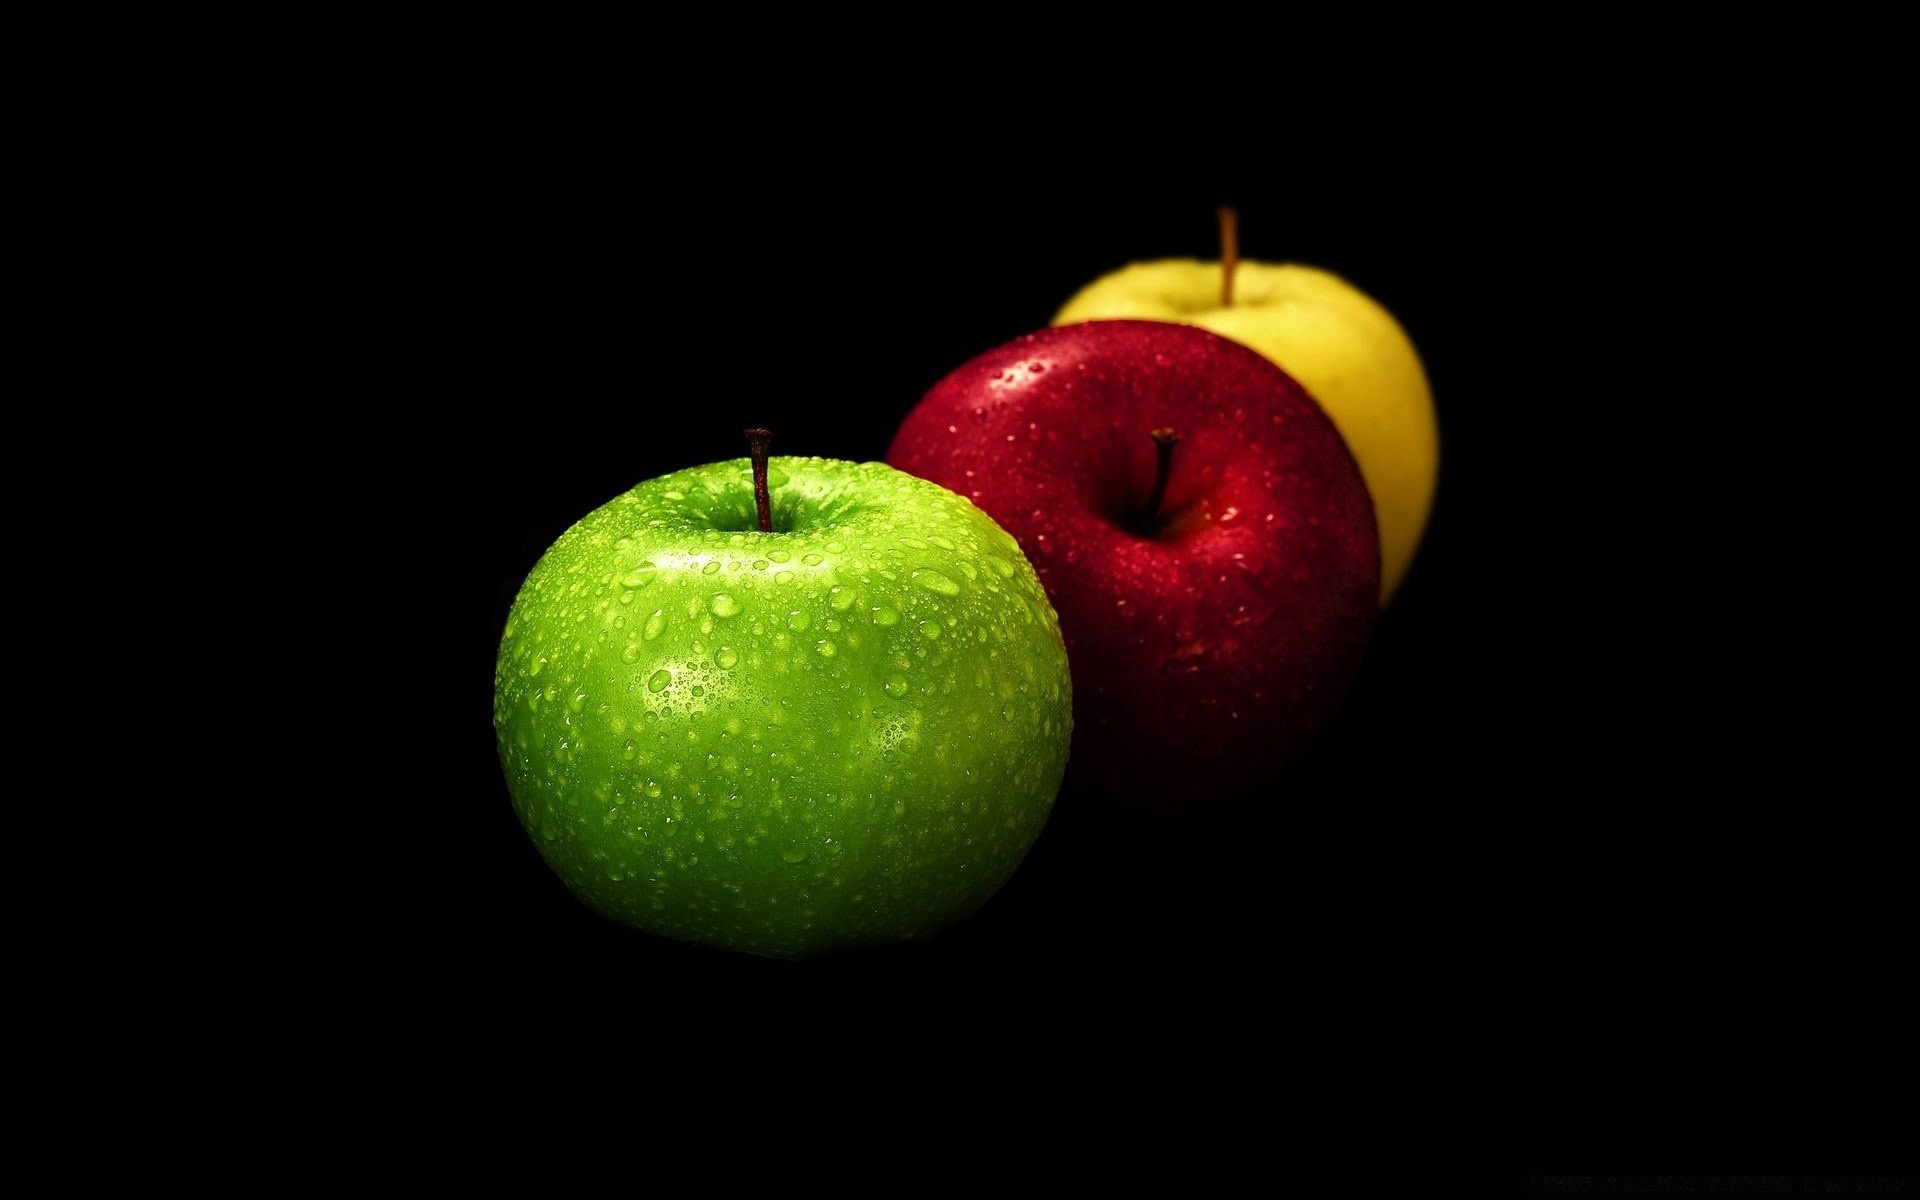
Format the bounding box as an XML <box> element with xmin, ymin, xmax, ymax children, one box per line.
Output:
<box><xmin>493</xmin><ymin>457</ymin><xmax>1073</xmax><ymax>958</ymax></box>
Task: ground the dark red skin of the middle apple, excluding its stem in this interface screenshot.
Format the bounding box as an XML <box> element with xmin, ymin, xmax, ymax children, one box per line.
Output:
<box><xmin>887</xmin><ymin>321</ymin><xmax>1380</xmax><ymax>804</ymax></box>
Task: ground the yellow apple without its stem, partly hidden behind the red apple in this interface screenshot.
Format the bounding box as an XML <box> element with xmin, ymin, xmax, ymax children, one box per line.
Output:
<box><xmin>1054</xmin><ymin>255</ymin><xmax>1440</xmax><ymax>607</ymax></box>
